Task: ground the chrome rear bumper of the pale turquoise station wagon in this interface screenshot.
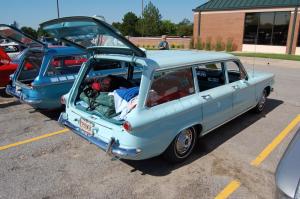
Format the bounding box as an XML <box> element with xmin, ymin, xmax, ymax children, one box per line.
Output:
<box><xmin>58</xmin><ymin>113</ymin><xmax>141</xmax><ymax>160</ymax></box>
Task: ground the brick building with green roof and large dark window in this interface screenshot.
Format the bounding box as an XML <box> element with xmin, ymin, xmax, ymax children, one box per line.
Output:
<box><xmin>193</xmin><ymin>0</ymin><xmax>300</xmax><ymax>55</ymax></box>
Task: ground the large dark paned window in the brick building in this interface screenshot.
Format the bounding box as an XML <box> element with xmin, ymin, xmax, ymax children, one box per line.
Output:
<box><xmin>244</xmin><ymin>12</ymin><xmax>290</xmax><ymax>46</ymax></box>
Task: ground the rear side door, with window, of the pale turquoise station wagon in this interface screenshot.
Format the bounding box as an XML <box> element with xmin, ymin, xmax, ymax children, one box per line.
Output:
<box><xmin>195</xmin><ymin>62</ymin><xmax>233</xmax><ymax>132</ymax></box>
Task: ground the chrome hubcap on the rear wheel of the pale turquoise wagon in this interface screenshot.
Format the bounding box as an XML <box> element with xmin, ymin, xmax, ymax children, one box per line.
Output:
<box><xmin>175</xmin><ymin>129</ymin><xmax>193</xmax><ymax>155</ymax></box>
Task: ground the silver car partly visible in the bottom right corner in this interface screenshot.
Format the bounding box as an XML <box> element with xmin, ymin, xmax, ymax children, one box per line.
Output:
<box><xmin>275</xmin><ymin>128</ymin><xmax>300</xmax><ymax>199</ymax></box>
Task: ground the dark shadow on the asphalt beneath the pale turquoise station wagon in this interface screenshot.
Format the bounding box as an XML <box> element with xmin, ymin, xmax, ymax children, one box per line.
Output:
<box><xmin>122</xmin><ymin>99</ymin><xmax>283</xmax><ymax>176</ymax></box>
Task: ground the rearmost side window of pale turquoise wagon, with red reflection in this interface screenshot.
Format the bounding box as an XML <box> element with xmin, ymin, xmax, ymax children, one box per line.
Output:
<box><xmin>146</xmin><ymin>68</ymin><xmax>195</xmax><ymax>107</ymax></box>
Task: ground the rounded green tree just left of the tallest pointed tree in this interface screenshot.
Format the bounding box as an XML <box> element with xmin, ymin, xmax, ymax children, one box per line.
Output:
<box><xmin>120</xmin><ymin>12</ymin><xmax>139</xmax><ymax>36</ymax></box>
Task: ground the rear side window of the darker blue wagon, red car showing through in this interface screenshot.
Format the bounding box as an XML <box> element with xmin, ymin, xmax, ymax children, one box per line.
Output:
<box><xmin>46</xmin><ymin>55</ymin><xmax>87</xmax><ymax>76</ymax></box>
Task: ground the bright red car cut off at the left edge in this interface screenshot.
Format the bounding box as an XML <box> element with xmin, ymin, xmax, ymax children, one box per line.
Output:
<box><xmin>0</xmin><ymin>47</ymin><xmax>18</xmax><ymax>87</ymax></box>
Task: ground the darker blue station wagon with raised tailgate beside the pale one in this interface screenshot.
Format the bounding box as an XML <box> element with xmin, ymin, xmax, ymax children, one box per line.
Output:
<box><xmin>0</xmin><ymin>25</ymin><xmax>87</xmax><ymax>109</ymax></box>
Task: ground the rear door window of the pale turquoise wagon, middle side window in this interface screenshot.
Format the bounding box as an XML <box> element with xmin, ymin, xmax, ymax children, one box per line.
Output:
<box><xmin>195</xmin><ymin>62</ymin><xmax>226</xmax><ymax>92</ymax></box>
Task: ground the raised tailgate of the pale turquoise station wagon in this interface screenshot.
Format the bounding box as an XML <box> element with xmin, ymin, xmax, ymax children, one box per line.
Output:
<box><xmin>40</xmin><ymin>16</ymin><xmax>146</xmax><ymax>57</ymax></box>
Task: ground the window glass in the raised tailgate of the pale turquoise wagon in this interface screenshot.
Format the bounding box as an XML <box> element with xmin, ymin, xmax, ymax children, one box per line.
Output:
<box><xmin>44</xmin><ymin>21</ymin><xmax>126</xmax><ymax>48</ymax></box>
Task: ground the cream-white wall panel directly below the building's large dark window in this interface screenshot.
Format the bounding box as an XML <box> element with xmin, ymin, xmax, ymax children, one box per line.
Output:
<box><xmin>242</xmin><ymin>44</ymin><xmax>286</xmax><ymax>54</ymax></box>
